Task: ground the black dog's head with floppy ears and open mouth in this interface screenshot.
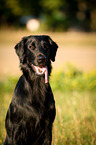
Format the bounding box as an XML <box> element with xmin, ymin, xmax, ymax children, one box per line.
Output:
<box><xmin>15</xmin><ymin>35</ymin><xmax>58</xmax><ymax>82</ymax></box>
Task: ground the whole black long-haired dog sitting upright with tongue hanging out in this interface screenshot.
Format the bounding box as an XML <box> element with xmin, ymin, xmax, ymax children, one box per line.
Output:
<box><xmin>4</xmin><ymin>35</ymin><xmax>58</xmax><ymax>145</ymax></box>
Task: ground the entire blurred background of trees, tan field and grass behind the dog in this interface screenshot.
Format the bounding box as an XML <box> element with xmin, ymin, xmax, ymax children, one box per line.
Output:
<box><xmin>0</xmin><ymin>0</ymin><xmax>96</xmax><ymax>145</ymax></box>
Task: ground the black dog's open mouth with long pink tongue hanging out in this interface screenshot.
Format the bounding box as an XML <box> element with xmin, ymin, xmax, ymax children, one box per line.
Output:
<box><xmin>32</xmin><ymin>64</ymin><xmax>48</xmax><ymax>83</ymax></box>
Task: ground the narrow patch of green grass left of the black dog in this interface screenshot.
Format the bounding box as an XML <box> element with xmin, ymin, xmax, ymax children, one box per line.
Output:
<box><xmin>0</xmin><ymin>77</ymin><xmax>17</xmax><ymax>145</ymax></box>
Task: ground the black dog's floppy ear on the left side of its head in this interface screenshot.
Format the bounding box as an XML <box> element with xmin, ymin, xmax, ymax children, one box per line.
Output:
<box><xmin>15</xmin><ymin>37</ymin><xmax>27</xmax><ymax>63</ymax></box>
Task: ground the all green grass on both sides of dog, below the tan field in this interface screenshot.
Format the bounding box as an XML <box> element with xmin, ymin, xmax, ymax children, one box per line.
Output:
<box><xmin>0</xmin><ymin>65</ymin><xmax>96</xmax><ymax>145</ymax></box>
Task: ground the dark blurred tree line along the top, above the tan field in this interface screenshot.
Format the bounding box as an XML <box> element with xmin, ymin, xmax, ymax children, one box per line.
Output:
<box><xmin>0</xmin><ymin>0</ymin><xmax>96</xmax><ymax>31</ymax></box>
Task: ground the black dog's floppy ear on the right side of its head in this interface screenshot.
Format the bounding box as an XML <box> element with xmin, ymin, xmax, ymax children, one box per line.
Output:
<box><xmin>49</xmin><ymin>37</ymin><xmax>58</xmax><ymax>62</ymax></box>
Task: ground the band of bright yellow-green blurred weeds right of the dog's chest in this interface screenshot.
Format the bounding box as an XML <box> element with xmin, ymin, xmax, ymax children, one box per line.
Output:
<box><xmin>51</xmin><ymin>64</ymin><xmax>96</xmax><ymax>92</ymax></box>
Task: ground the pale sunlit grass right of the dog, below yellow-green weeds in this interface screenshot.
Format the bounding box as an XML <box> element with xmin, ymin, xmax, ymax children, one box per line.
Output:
<box><xmin>53</xmin><ymin>92</ymin><xmax>96</xmax><ymax>145</ymax></box>
